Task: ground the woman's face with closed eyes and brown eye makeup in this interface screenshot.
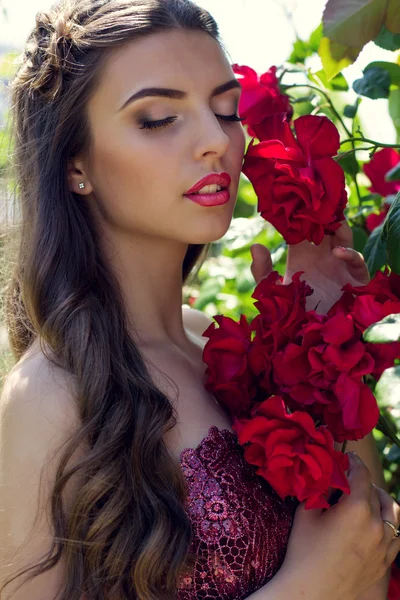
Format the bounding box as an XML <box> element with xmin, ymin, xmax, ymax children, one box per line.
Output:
<box><xmin>74</xmin><ymin>30</ymin><xmax>245</xmax><ymax>244</ymax></box>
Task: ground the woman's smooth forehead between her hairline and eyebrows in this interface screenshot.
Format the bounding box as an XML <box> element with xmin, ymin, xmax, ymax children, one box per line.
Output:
<box><xmin>90</xmin><ymin>30</ymin><xmax>233</xmax><ymax>110</ymax></box>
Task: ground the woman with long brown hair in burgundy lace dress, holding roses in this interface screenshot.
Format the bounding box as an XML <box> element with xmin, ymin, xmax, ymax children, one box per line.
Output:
<box><xmin>0</xmin><ymin>0</ymin><xmax>400</xmax><ymax>600</ymax></box>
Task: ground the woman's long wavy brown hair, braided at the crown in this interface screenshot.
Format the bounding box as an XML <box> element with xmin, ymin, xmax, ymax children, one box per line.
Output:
<box><xmin>0</xmin><ymin>0</ymin><xmax>222</xmax><ymax>600</ymax></box>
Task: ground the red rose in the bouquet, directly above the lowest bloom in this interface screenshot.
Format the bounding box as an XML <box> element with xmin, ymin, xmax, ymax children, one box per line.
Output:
<box><xmin>272</xmin><ymin>311</ymin><xmax>379</xmax><ymax>441</ymax></box>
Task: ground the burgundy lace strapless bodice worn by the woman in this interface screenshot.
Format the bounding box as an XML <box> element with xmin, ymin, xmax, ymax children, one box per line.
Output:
<box><xmin>177</xmin><ymin>425</ymin><xmax>298</xmax><ymax>600</ymax></box>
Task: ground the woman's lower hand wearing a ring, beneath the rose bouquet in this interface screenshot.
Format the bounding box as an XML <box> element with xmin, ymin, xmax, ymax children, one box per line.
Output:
<box><xmin>281</xmin><ymin>455</ymin><xmax>400</xmax><ymax>600</ymax></box>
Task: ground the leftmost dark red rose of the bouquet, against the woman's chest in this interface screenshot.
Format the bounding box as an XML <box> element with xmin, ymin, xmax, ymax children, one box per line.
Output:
<box><xmin>203</xmin><ymin>315</ymin><xmax>256</xmax><ymax>415</ymax></box>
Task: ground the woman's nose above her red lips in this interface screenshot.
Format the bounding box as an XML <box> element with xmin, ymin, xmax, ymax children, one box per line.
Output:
<box><xmin>193</xmin><ymin>110</ymin><xmax>231</xmax><ymax>159</ymax></box>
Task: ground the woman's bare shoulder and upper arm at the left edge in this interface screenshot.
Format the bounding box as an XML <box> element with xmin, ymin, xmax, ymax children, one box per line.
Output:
<box><xmin>0</xmin><ymin>355</ymin><xmax>85</xmax><ymax>600</ymax></box>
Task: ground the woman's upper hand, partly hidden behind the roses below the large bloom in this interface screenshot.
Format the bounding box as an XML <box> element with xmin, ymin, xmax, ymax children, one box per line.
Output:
<box><xmin>251</xmin><ymin>221</ymin><xmax>370</xmax><ymax>314</ymax></box>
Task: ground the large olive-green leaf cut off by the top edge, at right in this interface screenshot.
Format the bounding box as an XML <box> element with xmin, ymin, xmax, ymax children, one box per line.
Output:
<box><xmin>322</xmin><ymin>0</ymin><xmax>387</xmax><ymax>47</ymax></box>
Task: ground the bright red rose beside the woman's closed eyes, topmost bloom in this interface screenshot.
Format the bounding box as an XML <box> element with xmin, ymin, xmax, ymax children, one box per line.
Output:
<box><xmin>232</xmin><ymin>64</ymin><xmax>293</xmax><ymax>137</ymax></box>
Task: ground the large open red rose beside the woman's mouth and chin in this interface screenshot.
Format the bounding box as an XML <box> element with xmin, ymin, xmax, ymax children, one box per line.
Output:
<box><xmin>242</xmin><ymin>115</ymin><xmax>347</xmax><ymax>244</ymax></box>
